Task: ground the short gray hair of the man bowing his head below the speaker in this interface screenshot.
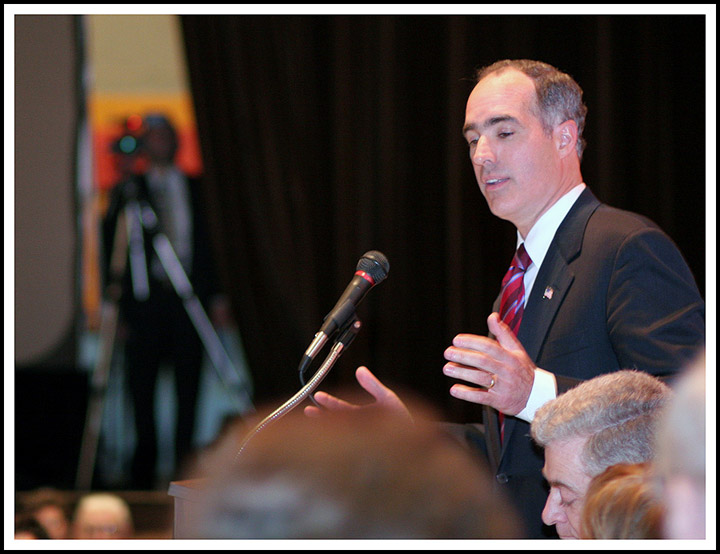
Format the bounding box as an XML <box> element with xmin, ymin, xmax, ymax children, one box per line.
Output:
<box><xmin>530</xmin><ymin>370</ymin><xmax>672</xmax><ymax>477</ymax></box>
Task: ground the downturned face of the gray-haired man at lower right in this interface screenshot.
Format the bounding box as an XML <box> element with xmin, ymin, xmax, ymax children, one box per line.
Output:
<box><xmin>542</xmin><ymin>437</ymin><xmax>592</xmax><ymax>539</ymax></box>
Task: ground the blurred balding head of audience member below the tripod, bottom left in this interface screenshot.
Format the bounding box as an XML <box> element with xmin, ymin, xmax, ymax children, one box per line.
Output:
<box><xmin>72</xmin><ymin>493</ymin><xmax>135</xmax><ymax>539</ymax></box>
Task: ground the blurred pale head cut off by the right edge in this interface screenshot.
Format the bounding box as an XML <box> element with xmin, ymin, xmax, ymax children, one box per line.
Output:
<box><xmin>655</xmin><ymin>353</ymin><xmax>706</xmax><ymax>539</ymax></box>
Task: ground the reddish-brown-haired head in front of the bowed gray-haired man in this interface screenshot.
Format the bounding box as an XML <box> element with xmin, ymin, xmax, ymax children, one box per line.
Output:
<box><xmin>580</xmin><ymin>462</ymin><xmax>663</xmax><ymax>539</ymax></box>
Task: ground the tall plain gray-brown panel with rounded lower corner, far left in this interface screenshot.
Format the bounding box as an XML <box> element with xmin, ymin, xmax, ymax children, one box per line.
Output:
<box><xmin>14</xmin><ymin>15</ymin><xmax>76</xmax><ymax>365</ymax></box>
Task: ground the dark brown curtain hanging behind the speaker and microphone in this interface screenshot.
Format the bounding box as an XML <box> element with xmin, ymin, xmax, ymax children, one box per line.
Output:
<box><xmin>182</xmin><ymin>15</ymin><xmax>705</xmax><ymax>421</ymax></box>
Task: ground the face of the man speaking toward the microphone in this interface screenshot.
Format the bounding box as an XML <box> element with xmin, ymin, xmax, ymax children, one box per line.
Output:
<box><xmin>463</xmin><ymin>69</ymin><xmax>579</xmax><ymax>236</ymax></box>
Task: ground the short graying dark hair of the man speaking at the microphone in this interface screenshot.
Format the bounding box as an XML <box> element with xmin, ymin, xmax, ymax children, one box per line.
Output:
<box><xmin>475</xmin><ymin>60</ymin><xmax>587</xmax><ymax>160</ymax></box>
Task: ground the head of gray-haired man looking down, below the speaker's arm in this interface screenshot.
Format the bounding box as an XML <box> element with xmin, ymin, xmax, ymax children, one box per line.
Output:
<box><xmin>531</xmin><ymin>370</ymin><xmax>672</xmax><ymax>539</ymax></box>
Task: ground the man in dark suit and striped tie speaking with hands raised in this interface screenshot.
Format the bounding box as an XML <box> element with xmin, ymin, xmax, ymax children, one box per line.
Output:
<box><xmin>307</xmin><ymin>60</ymin><xmax>705</xmax><ymax>538</ymax></box>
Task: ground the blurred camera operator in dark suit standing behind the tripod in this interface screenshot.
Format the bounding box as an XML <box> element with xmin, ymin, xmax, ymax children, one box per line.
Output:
<box><xmin>103</xmin><ymin>115</ymin><xmax>222</xmax><ymax>489</ymax></box>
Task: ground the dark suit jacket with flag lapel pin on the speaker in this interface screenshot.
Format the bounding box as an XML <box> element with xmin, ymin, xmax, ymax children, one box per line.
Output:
<box><xmin>484</xmin><ymin>189</ymin><xmax>705</xmax><ymax>537</ymax></box>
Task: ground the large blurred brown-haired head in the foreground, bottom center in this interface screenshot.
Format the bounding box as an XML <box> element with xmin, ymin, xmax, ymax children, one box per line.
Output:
<box><xmin>191</xmin><ymin>398</ymin><xmax>521</xmax><ymax>539</ymax></box>
